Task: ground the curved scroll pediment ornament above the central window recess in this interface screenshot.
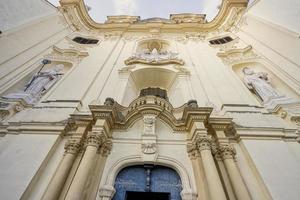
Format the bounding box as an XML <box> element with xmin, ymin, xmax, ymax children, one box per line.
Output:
<box><xmin>125</xmin><ymin>48</ymin><xmax>184</xmax><ymax>65</ymax></box>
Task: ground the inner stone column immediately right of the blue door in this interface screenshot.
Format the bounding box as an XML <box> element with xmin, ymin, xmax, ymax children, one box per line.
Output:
<box><xmin>196</xmin><ymin>134</ymin><xmax>226</xmax><ymax>200</ymax></box>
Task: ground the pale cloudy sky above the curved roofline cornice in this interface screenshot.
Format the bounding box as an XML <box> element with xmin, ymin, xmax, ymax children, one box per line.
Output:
<box><xmin>48</xmin><ymin>0</ymin><xmax>222</xmax><ymax>22</ymax></box>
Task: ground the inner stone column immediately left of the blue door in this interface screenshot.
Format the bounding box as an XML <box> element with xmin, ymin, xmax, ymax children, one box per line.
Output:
<box><xmin>65</xmin><ymin>129</ymin><xmax>104</xmax><ymax>200</ymax></box>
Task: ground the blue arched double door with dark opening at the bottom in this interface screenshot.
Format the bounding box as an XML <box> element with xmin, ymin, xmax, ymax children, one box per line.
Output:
<box><xmin>113</xmin><ymin>165</ymin><xmax>182</xmax><ymax>200</ymax></box>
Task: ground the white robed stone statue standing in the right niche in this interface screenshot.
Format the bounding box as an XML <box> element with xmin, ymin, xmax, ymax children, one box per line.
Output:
<box><xmin>243</xmin><ymin>67</ymin><xmax>280</xmax><ymax>103</ymax></box>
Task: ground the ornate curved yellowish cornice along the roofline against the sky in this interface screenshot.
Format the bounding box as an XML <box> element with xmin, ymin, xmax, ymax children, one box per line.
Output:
<box><xmin>60</xmin><ymin>0</ymin><xmax>248</xmax><ymax>32</ymax></box>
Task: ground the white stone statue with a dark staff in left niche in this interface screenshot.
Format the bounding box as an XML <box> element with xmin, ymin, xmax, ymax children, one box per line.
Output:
<box><xmin>3</xmin><ymin>64</ymin><xmax>64</xmax><ymax>104</ymax></box>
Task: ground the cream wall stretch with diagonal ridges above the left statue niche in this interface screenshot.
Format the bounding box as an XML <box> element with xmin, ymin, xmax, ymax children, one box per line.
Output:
<box><xmin>0</xmin><ymin>12</ymin><xmax>70</xmax><ymax>94</ymax></box>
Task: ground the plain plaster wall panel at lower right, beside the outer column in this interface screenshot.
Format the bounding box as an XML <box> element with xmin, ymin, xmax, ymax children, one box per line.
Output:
<box><xmin>243</xmin><ymin>140</ymin><xmax>300</xmax><ymax>200</ymax></box>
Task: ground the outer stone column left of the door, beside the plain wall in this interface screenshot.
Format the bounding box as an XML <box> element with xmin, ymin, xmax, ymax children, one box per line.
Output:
<box><xmin>42</xmin><ymin>125</ymin><xmax>87</xmax><ymax>200</ymax></box>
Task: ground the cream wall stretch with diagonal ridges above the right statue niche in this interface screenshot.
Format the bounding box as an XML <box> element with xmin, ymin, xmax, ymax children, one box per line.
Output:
<box><xmin>236</xmin><ymin>14</ymin><xmax>300</xmax><ymax>94</ymax></box>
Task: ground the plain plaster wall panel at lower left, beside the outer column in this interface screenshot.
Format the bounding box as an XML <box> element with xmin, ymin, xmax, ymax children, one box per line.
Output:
<box><xmin>0</xmin><ymin>134</ymin><xmax>58</xmax><ymax>200</ymax></box>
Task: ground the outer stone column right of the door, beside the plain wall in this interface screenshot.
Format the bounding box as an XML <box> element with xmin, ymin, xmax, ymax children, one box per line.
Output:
<box><xmin>219</xmin><ymin>144</ymin><xmax>251</xmax><ymax>200</ymax></box>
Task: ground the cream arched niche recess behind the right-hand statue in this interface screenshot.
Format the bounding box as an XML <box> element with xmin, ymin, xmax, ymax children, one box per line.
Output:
<box><xmin>232</xmin><ymin>61</ymin><xmax>299</xmax><ymax>102</ymax></box>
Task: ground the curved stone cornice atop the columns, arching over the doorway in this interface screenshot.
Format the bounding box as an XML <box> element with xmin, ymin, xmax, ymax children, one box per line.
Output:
<box><xmin>89</xmin><ymin>96</ymin><xmax>212</xmax><ymax>132</ymax></box>
